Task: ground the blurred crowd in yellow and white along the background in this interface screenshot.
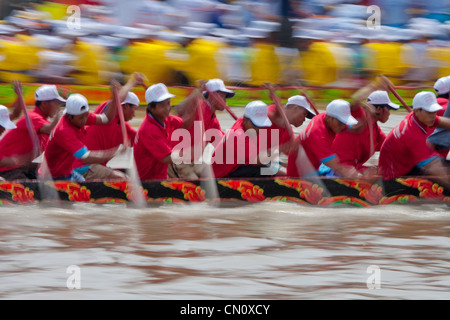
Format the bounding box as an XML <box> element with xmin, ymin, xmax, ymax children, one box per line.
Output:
<box><xmin>0</xmin><ymin>0</ymin><xmax>450</xmax><ymax>86</ymax></box>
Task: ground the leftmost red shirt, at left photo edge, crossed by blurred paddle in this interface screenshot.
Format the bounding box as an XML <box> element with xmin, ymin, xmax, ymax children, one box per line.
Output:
<box><xmin>0</xmin><ymin>107</ymin><xmax>50</xmax><ymax>171</ymax></box>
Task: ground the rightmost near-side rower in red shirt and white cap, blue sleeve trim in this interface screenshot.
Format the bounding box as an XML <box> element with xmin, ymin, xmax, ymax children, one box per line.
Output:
<box><xmin>379</xmin><ymin>91</ymin><xmax>450</xmax><ymax>188</ymax></box>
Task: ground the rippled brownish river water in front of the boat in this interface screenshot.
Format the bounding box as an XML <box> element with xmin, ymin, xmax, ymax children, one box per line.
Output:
<box><xmin>0</xmin><ymin>203</ymin><xmax>450</xmax><ymax>299</ymax></box>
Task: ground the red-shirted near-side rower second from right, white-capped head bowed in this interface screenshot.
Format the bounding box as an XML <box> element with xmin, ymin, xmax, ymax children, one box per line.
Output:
<box><xmin>287</xmin><ymin>99</ymin><xmax>359</xmax><ymax>177</ymax></box>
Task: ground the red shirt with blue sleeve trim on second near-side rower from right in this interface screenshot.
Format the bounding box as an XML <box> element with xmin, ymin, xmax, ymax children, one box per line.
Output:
<box><xmin>286</xmin><ymin>112</ymin><xmax>336</xmax><ymax>177</ymax></box>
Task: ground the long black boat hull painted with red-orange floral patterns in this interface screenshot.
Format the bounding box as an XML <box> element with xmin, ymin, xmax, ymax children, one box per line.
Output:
<box><xmin>0</xmin><ymin>177</ymin><xmax>450</xmax><ymax>207</ymax></box>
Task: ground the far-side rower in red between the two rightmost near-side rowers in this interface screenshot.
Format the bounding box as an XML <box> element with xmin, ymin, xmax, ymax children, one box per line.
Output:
<box><xmin>333</xmin><ymin>90</ymin><xmax>399</xmax><ymax>174</ymax></box>
